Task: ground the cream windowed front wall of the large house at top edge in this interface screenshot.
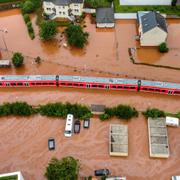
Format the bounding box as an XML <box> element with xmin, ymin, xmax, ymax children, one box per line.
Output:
<box><xmin>43</xmin><ymin>1</ymin><xmax>83</xmax><ymax>18</ymax></box>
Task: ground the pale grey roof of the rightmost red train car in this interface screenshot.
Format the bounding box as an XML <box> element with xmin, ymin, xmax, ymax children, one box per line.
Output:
<box><xmin>141</xmin><ymin>80</ymin><xmax>180</xmax><ymax>89</ymax></box>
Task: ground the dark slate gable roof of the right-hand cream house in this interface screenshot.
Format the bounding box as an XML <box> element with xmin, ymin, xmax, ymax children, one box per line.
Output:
<box><xmin>141</xmin><ymin>11</ymin><xmax>167</xmax><ymax>33</ymax></box>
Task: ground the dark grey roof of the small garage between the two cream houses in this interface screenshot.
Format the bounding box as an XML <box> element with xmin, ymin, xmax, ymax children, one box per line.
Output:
<box><xmin>96</xmin><ymin>8</ymin><xmax>114</xmax><ymax>23</ymax></box>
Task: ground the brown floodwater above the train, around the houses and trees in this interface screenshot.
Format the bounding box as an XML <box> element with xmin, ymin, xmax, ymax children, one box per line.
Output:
<box><xmin>0</xmin><ymin>10</ymin><xmax>180</xmax><ymax>82</ymax></box>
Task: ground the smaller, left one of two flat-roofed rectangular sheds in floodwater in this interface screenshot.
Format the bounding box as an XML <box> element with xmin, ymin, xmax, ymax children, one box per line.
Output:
<box><xmin>109</xmin><ymin>124</ymin><xmax>128</xmax><ymax>156</ymax></box>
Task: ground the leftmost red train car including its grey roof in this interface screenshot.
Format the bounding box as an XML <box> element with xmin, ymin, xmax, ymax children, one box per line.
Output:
<box><xmin>0</xmin><ymin>75</ymin><xmax>56</xmax><ymax>87</ymax></box>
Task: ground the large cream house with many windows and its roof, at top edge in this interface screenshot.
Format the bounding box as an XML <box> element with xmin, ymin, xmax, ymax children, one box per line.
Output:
<box><xmin>43</xmin><ymin>0</ymin><xmax>84</xmax><ymax>20</ymax></box>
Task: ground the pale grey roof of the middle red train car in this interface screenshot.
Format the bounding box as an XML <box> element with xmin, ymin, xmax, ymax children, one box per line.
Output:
<box><xmin>59</xmin><ymin>76</ymin><xmax>138</xmax><ymax>85</ymax></box>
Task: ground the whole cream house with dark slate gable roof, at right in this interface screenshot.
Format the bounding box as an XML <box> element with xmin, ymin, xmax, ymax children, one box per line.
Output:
<box><xmin>137</xmin><ymin>11</ymin><xmax>168</xmax><ymax>46</ymax></box>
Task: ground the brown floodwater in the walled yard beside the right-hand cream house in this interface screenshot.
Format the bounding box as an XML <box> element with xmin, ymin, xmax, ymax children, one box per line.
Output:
<box><xmin>136</xmin><ymin>19</ymin><xmax>180</xmax><ymax>67</ymax></box>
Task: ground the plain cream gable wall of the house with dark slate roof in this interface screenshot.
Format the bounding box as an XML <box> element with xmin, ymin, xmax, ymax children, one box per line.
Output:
<box><xmin>140</xmin><ymin>27</ymin><xmax>167</xmax><ymax>46</ymax></box>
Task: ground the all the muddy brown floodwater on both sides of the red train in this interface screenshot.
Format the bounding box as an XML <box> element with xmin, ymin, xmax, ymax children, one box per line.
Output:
<box><xmin>0</xmin><ymin>10</ymin><xmax>180</xmax><ymax>180</ymax></box>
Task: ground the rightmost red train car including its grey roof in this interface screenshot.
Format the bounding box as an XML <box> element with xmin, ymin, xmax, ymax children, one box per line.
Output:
<box><xmin>140</xmin><ymin>80</ymin><xmax>180</xmax><ymax>95</ymax></box>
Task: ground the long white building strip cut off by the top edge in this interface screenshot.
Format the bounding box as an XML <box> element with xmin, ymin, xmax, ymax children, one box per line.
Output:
<box><xmin>119</xmin><ymin>0</ymin><xmax>171</xmax><ymax>5</ymax></box>
